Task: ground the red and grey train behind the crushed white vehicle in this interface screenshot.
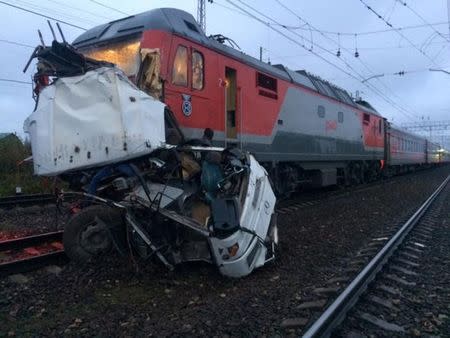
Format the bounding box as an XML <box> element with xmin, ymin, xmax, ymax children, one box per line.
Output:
<box><xmin>73</xmin><ymin>8</ymin><xmax>446</xmax><ymax>192</ymax></box>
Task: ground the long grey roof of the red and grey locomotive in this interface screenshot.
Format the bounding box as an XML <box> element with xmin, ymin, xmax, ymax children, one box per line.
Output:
<box><xmin>73</xmin><ymin>8</ymin><xmax>356</xmax><ymax>108</ymax></box>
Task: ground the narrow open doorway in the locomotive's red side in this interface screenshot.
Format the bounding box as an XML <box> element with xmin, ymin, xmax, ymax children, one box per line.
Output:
<box><xmin>224</xmin><ymin>67</ymin><xmax>238</xmax><ymax>146</ymax></box>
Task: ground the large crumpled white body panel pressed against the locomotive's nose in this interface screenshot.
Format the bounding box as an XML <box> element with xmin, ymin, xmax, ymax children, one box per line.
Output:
<box><xmin>24</xmin><ymin>67</ymin><xmax>165</xmax><ymax>175</ymax></box>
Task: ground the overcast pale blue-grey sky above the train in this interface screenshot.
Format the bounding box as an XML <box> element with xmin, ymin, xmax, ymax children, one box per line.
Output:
<box><xmin>0</xmin><ymin>0</ymin><xmax>450</xmax><ymax>144</ymax></box>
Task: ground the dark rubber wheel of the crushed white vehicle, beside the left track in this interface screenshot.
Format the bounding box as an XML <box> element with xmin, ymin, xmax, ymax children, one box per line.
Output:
<box><xmin>63</xmin><ymin>205</ymin><xmax>122</xmax><ymax>263</ymax></box>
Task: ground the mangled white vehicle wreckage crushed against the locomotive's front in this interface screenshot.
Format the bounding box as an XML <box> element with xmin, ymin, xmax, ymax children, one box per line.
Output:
<box><xmin>24</xmin><ymin>41</ymin><xmax>277</xmax><ymax>277</ymax></box>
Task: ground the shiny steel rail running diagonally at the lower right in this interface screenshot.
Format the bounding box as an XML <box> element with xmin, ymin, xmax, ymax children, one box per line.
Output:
<box><xmin>303</xmin><ymin>175</ymin><xmax>450</xmax><ymax>337</ymax></box>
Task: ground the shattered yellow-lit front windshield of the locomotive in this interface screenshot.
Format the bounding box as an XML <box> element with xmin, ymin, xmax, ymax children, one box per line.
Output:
<box><xmin>81</xmin><ymin>40</ymin><xmax>140</xmax><ymax>76</ymax></box>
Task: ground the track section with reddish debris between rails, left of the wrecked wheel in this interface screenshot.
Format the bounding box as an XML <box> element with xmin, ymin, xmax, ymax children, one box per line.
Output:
<box><xmin>0</xmin><ymin>231</ymin><xmax>67</xmax><ymax>276</ymax></box>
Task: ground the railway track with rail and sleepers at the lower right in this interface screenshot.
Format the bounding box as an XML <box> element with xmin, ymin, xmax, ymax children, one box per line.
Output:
<box><xmin>293</xmin><ymin>176</ymin><xmax>450</xmax><ymax>337</ymax></box>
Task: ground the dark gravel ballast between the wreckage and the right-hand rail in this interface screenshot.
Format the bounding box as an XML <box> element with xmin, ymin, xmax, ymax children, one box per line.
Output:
<box><xmin>0</xmin><ymin>167</ymin><xmax>450</xmax><ymax>336</ymax></box>
